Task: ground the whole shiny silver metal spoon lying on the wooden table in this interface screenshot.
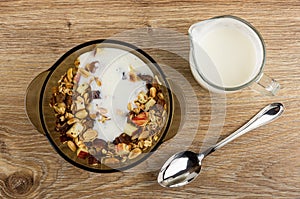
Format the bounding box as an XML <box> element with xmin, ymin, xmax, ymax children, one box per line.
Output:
<box><xmin>157</xmin><ymin>103</ymin><xmax>284</xmax><ymax>187</ymax></box>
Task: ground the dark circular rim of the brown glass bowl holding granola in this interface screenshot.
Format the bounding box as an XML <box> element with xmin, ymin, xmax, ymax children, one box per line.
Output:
<box><xmin>38</xmin><ymin>39</ymin><xmax>174</xmax><ymax>173</ymax></box>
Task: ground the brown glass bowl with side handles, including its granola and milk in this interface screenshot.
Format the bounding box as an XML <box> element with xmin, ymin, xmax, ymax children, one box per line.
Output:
<box><xmin>26</xmin><ymin>40</ymin><xmax>180</xmax><ymax>172</ymax></box>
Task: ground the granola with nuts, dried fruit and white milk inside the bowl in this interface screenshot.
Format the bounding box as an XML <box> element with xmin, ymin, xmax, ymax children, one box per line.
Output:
<box><xmin>50</xmin><ymin>44</ymin><xmax>169</xmax><ymax>169</ymax></box>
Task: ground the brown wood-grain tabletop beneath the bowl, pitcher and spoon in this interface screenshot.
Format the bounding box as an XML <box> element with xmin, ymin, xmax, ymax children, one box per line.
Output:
<box><xmin>0</xmin><ymin>0</ymin><xmax>300</xmax><ymax>198</ymax></box>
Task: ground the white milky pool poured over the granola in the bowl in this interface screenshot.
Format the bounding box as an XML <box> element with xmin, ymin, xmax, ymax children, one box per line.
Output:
<box><xmin>79</xmin><ymin>47</ymin><xmax>153</xmax><ymax>141</ymax></box>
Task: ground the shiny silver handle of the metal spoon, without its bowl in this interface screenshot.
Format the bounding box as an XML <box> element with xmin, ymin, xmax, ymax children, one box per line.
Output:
<box><xmin>202</xmin><ymin>103</ymin><xmax>284</xmax><ymax>157</ymax></box>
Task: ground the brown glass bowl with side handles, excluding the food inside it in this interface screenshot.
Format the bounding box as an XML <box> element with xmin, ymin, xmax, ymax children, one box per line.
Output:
<box><xmin>26</xmin><ymin>40</ymin><xmax>180</xmax><ymax>172</ymax></box>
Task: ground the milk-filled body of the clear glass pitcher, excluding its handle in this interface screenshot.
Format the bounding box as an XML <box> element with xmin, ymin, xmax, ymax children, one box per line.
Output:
<box><xmin>189</xmin><ymin>18</ymin><xmax>264</xmax><ymax>89</ymax></box>
